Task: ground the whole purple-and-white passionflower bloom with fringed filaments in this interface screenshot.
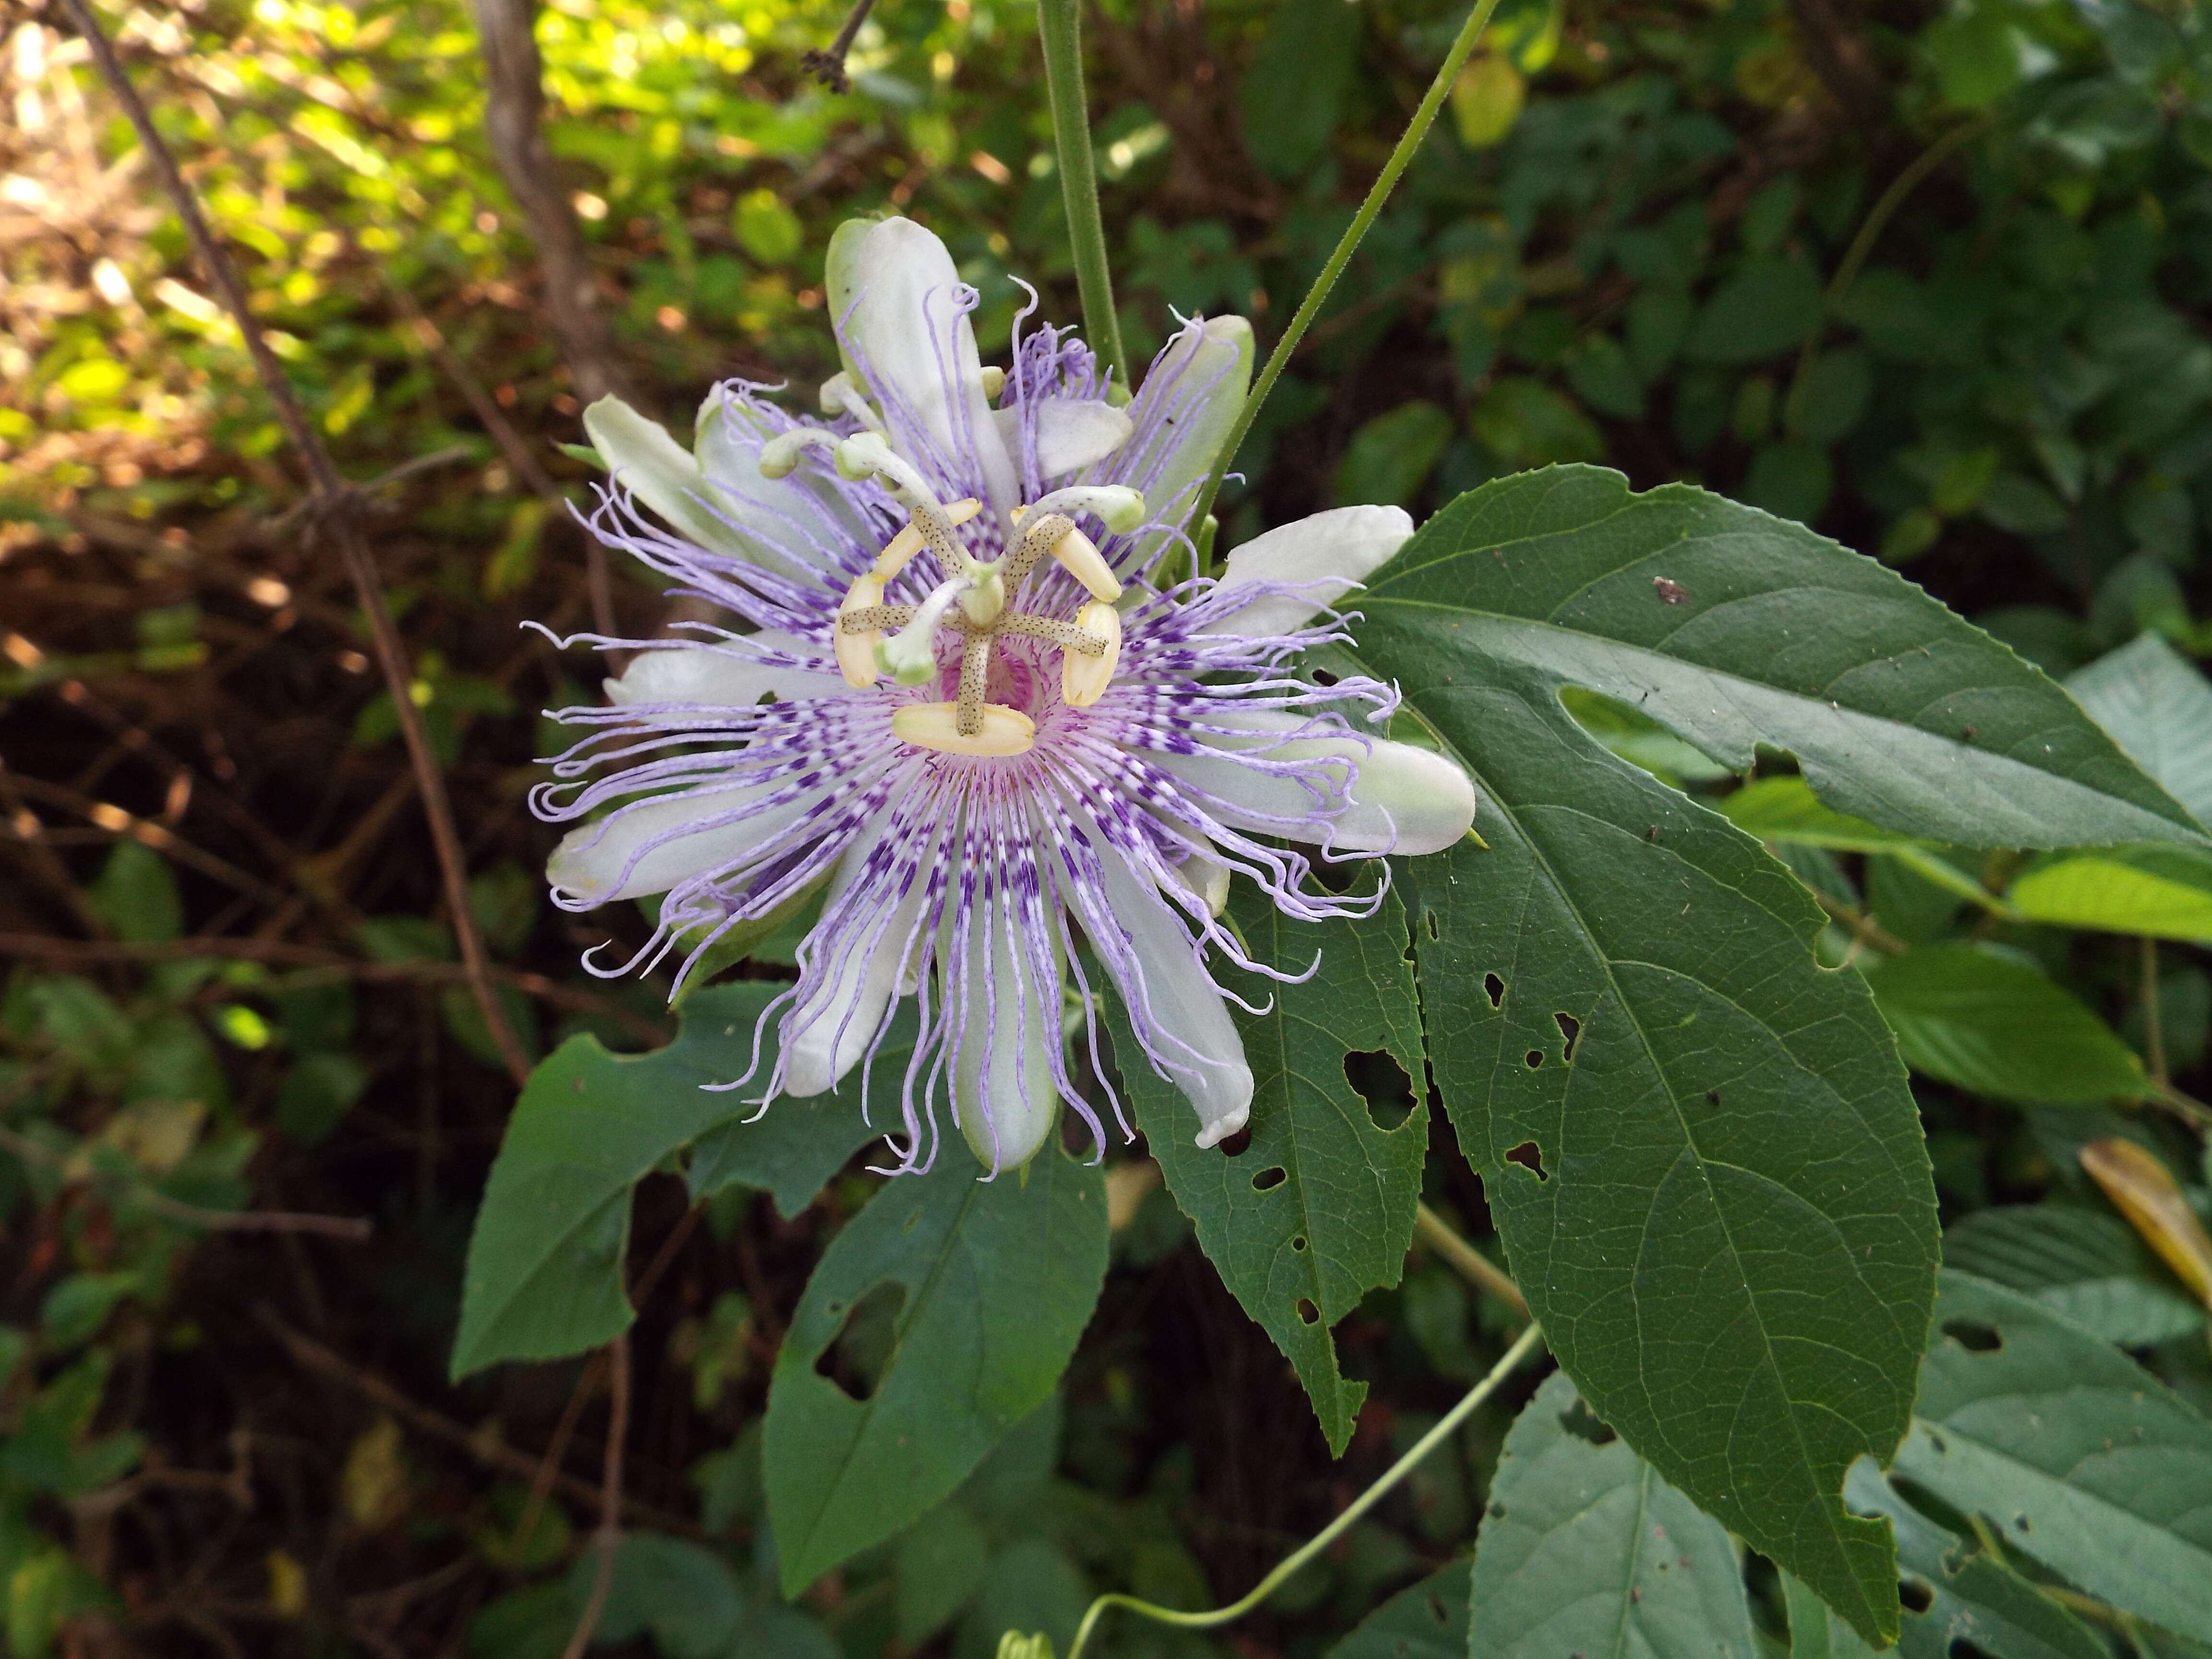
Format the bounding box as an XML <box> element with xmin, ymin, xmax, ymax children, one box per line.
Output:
<box><xmin>533</xmin><ymin>219</ymin><xmax>1476</xmax><ymax>1172</ymax></box>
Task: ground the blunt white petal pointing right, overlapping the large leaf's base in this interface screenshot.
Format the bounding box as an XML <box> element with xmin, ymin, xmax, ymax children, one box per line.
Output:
<box><xmin>1146</xmin><ymin>708</ymin><xmax>1476</xmax><ymax>856</ymax></box>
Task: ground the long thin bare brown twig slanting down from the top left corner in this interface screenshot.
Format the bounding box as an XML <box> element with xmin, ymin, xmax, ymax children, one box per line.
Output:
<box><xmin>62</xmin><ymin>0</ymin><xmax>531</xmax><ymax>1084</ymax></box>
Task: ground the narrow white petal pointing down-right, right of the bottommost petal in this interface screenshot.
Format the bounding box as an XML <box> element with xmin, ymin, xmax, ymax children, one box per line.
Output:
<box><xmin>1099</xmin><ymin>852</ymin><xmax>1252</xmax><ymax>1146</ymax></box>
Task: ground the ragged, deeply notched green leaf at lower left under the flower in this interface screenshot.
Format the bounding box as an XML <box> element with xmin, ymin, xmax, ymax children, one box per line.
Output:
<box><xmin>451</xmin><ymin>982</ymin><xmax>874</xmax><ymax>1378</ymax></box>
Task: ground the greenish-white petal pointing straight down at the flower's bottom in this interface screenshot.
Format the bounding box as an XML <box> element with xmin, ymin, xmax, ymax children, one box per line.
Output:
<box><xmin>938</xmin><ymin>905</ymin><xmax>1059</xmax><ymax>1172</ymax></box>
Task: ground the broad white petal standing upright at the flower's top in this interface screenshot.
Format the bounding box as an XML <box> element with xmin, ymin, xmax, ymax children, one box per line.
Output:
<box><xmin>827</xmin><ymin>219</ymin><xmax>1018</xmax><ymax>511</ymax></box>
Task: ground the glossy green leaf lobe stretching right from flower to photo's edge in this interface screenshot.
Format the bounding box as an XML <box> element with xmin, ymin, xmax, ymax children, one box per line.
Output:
<box><xmin>1360</xmin><ymin>467</ymin><xmax>2205</xmax><ymax>847</ymax></box>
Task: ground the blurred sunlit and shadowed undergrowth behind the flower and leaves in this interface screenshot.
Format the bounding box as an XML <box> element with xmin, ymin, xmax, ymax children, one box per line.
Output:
<box><xmin>0</xmin><ymin>0</ymin><xmax>2212</xmax><ymax>1659</ymax></box>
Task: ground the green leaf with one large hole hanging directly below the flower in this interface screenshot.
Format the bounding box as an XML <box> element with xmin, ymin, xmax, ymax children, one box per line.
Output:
<box><xmin>761</xmin><ymin>1142</ymin><xmax>1106</xmax><ymax>1595</ymax></box>
